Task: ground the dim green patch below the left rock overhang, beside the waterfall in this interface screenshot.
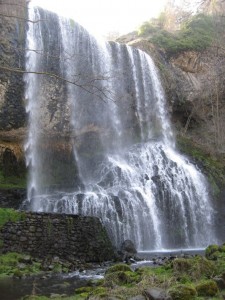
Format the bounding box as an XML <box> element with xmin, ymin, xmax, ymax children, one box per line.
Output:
<box><xmin>0</xmin><ymin>170</ymin><xmax>27</xmax><ymax>189</ymax></box>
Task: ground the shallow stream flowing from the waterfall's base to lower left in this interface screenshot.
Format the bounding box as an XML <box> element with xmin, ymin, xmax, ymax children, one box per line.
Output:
<box><xmin>0</xmin><ymin>249</ymin><xmax>204</xmax><ymax>300</ymax></box>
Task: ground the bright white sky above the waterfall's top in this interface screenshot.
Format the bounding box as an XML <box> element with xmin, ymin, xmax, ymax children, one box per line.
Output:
<box><xmin>32</xmin><ymin>0</ymin><xmax>165</xmax><ymax>36</ymax></box>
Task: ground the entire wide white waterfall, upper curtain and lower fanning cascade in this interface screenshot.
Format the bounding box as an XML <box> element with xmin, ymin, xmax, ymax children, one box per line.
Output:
<box><xmin>25</xmin><ymin>7</ymin><xmax>215</xmax><ymax>250</ymax></box>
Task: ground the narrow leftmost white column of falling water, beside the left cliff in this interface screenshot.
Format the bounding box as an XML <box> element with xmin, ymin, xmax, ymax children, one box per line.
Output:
<box><xmin>25</xmin><ymin>5</ymin><xmax>43</xmax><ymax>206</ymax></box>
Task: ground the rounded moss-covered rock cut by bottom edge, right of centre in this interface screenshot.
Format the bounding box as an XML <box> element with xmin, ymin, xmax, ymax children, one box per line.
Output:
<box><xmin>168</xmin><ymin>284</ymin><xmax>197</xmax><ymax>300</ymax></box>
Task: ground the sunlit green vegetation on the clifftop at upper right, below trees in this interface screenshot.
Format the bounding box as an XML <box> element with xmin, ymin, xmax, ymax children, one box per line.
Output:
<box><xmin>139</xmin><ymin>14</ymin><xmax>215</xmax><ymax>55</ymax></box>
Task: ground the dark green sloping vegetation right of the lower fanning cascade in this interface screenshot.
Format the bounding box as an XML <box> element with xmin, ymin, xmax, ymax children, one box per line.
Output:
<box><xmin>177</xmin><ymin>136</ymin><xmax>225</xmax><ymax>196</ymax></box>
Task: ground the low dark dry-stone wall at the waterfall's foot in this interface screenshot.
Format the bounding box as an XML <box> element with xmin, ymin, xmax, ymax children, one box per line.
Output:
<box><xmin>0</xmin><ymin>212</ymin><xmax>114</xmax><ymax>262</ymax></box>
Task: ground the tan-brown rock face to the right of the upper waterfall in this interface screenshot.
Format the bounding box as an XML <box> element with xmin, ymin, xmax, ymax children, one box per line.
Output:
<box><xmin>127</xmin><ymin>39</ymin><xmax>225</xmax><ymax>155</ymax></box>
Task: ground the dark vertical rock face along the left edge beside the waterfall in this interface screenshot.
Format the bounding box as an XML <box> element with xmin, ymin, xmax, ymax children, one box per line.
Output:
<box><xmin>0</xmin><ymin>0</ymin><xmax>27</xmax><ymax>175</ymax></box>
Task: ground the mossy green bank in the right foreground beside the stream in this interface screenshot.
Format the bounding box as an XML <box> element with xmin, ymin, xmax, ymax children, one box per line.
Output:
<box><xmin>6</xmin><ymin>245</ymin><xmax>225</xmax><ymax>300</ymax></box>
